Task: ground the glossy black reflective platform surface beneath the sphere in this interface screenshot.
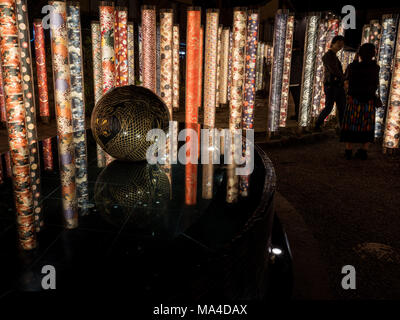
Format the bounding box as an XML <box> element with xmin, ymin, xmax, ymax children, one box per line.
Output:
<box><xmin>0</xmin><ymin>132</ymin><xmax>284</xmax><ymax>301</ymax></box>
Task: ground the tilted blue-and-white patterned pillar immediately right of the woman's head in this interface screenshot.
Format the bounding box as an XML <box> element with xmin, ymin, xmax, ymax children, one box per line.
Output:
<box><xmin>375</xmin><ymin>14</ymin><xmax>397</xmax><ymax>138</ymax></box>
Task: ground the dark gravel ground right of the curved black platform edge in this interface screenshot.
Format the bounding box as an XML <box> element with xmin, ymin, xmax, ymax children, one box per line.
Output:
<box><xmin>266</xmin><ymin>137</ymin><xmax>400</xmax><ymax>299</ymax></box>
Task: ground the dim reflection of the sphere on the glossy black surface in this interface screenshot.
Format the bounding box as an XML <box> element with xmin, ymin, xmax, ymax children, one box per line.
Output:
<box><xmin>94</xmin><ymin>161</ymin><xmax>170</xmax><ymax>232</ymax></box>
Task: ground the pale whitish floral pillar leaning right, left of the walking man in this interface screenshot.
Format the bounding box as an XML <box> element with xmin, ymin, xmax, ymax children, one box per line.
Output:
<box><xmin>298</xmin><ymin>15</ymin><xmax>320</xmax><ymax>127</ymax></box>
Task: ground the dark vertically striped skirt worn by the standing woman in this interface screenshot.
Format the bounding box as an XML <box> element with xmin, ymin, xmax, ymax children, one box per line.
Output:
<box><xmin>340</xmin><ymin>96</ymin><xmax>375</xmax><ymax>143</ymax></box>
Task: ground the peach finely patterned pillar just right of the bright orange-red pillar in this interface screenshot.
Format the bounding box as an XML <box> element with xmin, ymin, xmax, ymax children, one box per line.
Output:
<box><xmin>204</xmin><ymin>9</ymin><xmax>219</xmax><ymax>128</ymax></box>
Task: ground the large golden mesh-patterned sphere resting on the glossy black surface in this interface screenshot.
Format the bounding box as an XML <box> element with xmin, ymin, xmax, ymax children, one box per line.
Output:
<box><xmin>91</xmin><ymin>86</ymin><xmax>169</xmax><ymax>161</ymax></box>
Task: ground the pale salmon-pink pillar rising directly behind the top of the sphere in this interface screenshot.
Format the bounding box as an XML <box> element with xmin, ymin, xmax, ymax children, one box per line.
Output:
<box><xmin>141</xmin><ymin>6</ymin><xmax>157</xmax><ymax>92</ymax></box>
